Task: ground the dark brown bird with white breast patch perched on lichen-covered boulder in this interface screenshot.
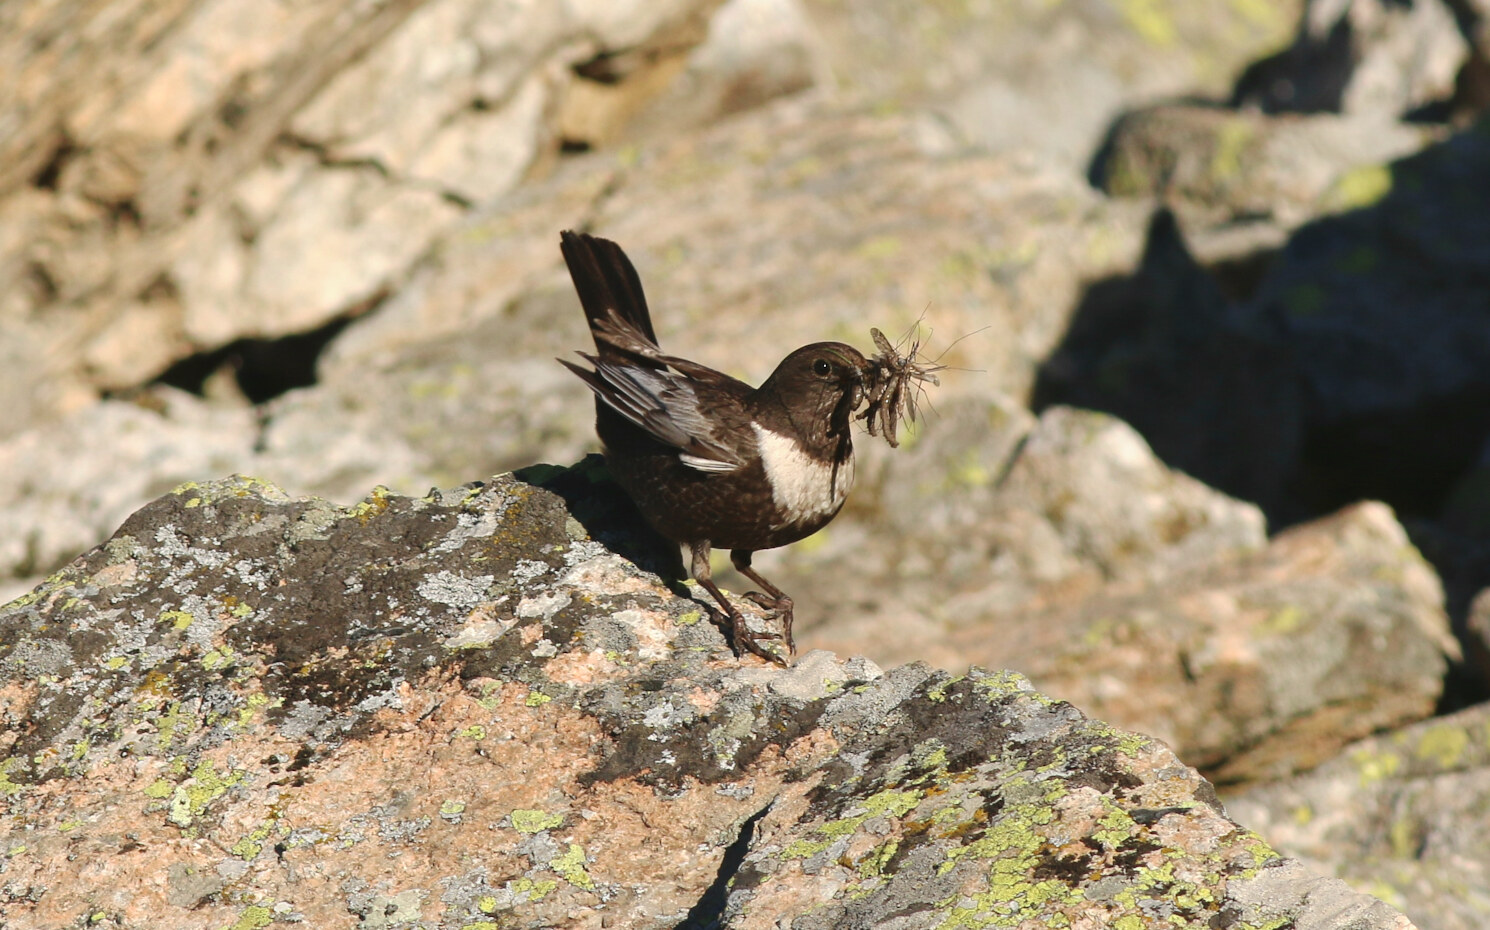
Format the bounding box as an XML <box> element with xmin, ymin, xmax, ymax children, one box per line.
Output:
<box><xmin>560</xmin><ymin>233</ymin><xmax>876</xmax><ymax>663</ymax></box>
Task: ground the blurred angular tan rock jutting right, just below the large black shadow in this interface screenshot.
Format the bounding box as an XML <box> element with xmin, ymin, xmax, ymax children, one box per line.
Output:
<box><xmin>946</xmin><ymin>504</ymin><xmax>1459</xmax><ymax>784</ymax></box>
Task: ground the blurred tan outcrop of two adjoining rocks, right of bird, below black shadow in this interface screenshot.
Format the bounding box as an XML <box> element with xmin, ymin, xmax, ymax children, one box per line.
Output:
<box><xmin>781</xmin><ymin>407</ymin><xmax>1459</xmax><ymax>782</ymax></box>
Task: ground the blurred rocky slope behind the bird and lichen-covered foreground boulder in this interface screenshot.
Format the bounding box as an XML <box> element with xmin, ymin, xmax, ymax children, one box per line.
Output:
<box><xmin>0</xmin><ymin>0</ymin><xmax>1490</xmax><ymax>930</ymax></box>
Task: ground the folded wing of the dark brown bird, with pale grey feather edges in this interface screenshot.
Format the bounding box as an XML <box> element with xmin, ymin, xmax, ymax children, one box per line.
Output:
<box><xmin>559</xmin><ymin>352</ymin><xmax>745</xmax><ymax>471</ymax></box>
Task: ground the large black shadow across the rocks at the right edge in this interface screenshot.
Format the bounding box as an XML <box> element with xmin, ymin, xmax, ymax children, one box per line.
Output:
<box><xmin>1033</xmin><ymin>121</ymin><xmax>1490</xmax><ymax>693</ymax></box>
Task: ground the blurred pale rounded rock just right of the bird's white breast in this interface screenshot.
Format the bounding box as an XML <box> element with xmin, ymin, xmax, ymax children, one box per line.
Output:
<box><xmin>780</xmin><ymin>398</ymin><xmax>1267</xmax><ymax>668</ymax></box>
